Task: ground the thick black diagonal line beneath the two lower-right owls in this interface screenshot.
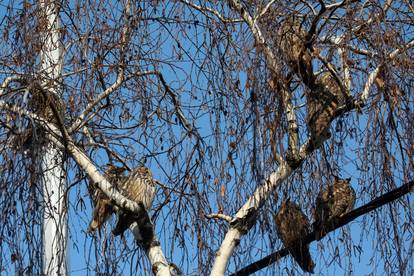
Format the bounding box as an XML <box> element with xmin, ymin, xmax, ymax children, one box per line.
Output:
<box><xmin>232</xmin><ymin>180</ymin><xmax>414</xmax><ymax>276</ymax></box>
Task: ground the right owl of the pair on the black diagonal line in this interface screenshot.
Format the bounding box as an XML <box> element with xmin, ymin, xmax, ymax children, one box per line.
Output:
<box><xmin>313</xmin><ymin>177</ymin><xmax>355</xmax><ymax>240</ymax></box>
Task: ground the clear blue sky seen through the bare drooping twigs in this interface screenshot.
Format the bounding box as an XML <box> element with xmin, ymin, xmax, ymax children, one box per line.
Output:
<box><xmin>0</xmin><ymin>2</ymin><xmax>413</xmax><ymax>275</ymax></box>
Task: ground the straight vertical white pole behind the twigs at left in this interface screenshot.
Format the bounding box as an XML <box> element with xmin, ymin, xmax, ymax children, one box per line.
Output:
<box><xmin>39</xmin><ymin>0</ymin><xmax>67</xmax><ymax>275</ymax></box>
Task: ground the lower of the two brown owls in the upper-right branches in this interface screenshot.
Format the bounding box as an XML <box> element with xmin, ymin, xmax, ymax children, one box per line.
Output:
<box><xmin>306</xmin><ymin>72</ymin><xmax>345</xmax><ymax>139</ymax></box>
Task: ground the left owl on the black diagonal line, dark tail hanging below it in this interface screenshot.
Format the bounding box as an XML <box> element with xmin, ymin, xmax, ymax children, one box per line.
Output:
<box><xmin>274</xmin><ymin>200</ymin><xmax>315</xmax><ymax>273</ymax></box>
